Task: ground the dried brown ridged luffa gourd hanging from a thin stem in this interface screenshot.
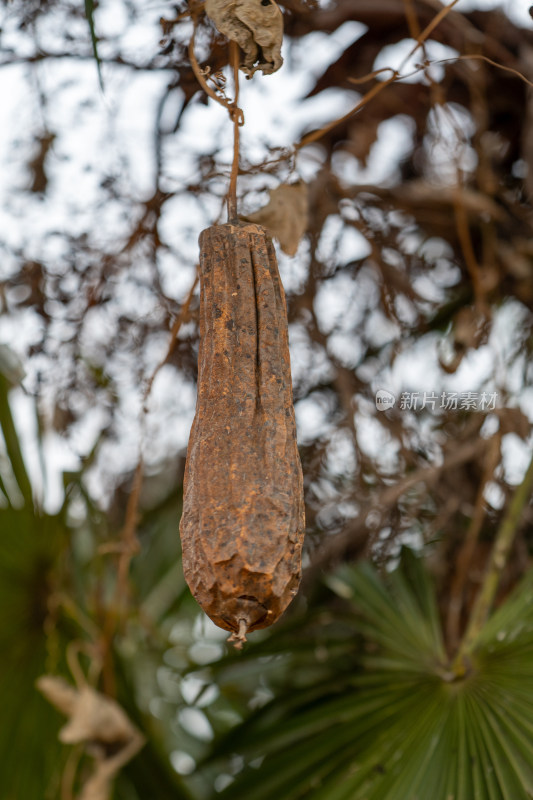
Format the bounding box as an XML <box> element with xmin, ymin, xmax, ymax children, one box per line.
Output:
<box><xmin>180</xmin><ymin>223</ymin><xmax>304</xmax><ymax>640</ymax></box>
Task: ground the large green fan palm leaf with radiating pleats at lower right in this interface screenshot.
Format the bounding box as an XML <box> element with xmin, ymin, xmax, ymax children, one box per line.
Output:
<box><xmin>206</xmin><ymin>551</ymin><xmax>533</xmax><ymax>800</ymax></box>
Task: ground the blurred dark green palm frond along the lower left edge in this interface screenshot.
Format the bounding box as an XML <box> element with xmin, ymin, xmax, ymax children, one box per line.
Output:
<box><xmin>0</xmin><ymin>506</ymin><xmax>70</xmax><ymax>800</ymax></box>
